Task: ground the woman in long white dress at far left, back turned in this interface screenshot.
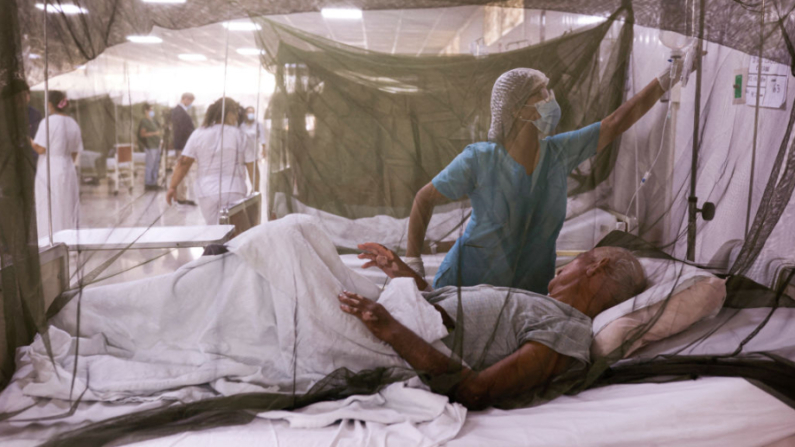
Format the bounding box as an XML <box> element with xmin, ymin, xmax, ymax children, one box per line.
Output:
<box><xmin>32</xmin><ymin>90</ymin><xmax>83</xmax><ymax>237</ymax></box>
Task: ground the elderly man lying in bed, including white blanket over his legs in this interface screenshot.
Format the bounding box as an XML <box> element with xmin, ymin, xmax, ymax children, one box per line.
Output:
<box><xmin>18</xmin><ymin>215</ymin><xmax>644</xmax><ymax>412</ymax></box>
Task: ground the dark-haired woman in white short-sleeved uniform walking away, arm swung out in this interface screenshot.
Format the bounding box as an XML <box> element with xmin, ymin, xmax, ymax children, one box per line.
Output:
<box><xmin>166</xmin><ymin>98</ymin><xmax>257</xmax><ymax>225</ymax></box>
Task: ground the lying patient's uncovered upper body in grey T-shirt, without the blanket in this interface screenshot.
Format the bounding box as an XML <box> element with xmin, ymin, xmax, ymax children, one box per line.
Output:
<box><xmin>339</xmin><ymin>243</ymin><xmax>645</xmax><ymax>409</ymax></box>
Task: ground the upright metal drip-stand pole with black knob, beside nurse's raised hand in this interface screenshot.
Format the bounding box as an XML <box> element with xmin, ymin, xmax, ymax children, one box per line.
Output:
<box><xmin>686</xmin><ymin>0</ymin><xmax>705</xmax><ymax>262</ymax></box>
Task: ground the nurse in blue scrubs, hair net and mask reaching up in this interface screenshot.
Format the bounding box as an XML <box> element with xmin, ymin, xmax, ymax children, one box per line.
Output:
<box><xmin>406</xmin><ymin>65</ymin><xmax>692</xmax><ymax>294</ymax></box>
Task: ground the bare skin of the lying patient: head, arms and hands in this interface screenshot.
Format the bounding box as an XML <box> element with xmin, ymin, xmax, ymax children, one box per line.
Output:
<box><xmin>338</xmin><ymin>243</ymin><xmax>645</xmax><ymax>409</ymax></box>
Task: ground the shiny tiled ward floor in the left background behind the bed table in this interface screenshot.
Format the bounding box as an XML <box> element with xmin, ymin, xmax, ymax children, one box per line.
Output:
<box><xmin>57</xmin><ymin>164</ymin><xmax>267</xmax><ymax>287</ymax></box>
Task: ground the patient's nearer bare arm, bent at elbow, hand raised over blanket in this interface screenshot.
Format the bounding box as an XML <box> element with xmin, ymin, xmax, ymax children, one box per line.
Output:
<box><xmin>338</xmin><ymin>292</ymin><xmax>569</xmax><ymax>410</ymax></box>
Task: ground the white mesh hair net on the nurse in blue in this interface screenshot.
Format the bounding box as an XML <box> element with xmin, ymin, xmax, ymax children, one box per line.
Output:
<box><xmin>489</xmin><ymin>68</ymin><xmax>549</xmax><ymax>143</ymax></box>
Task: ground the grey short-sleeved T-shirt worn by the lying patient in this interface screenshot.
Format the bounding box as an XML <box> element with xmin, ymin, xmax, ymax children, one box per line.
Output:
<box><xmin>423</xmin><ymin>285</ymin><xmax>592</xmax><ymax>371</ymax></box>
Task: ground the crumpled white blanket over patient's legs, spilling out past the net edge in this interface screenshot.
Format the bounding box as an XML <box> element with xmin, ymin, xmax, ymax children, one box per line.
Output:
<box><xmin>0</xmin><ymin>215</ymin><xmax>465</xmax><ymax>446</ymax></box>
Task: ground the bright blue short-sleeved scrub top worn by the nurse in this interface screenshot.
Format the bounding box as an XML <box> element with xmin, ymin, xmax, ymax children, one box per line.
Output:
<box><xmin>433</xmin><ymin>123</ymin><xmax>601</xmax><ymax>294</ymax></box>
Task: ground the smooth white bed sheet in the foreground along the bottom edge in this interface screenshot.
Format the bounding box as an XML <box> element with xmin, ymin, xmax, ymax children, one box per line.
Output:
<box><xmin>124</xmin><ymin>377</ymin><xmax>795</xmax><ymax>447</ymax></box>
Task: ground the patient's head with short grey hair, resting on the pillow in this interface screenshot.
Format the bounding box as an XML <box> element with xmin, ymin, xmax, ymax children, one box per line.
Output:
<box><xmin>549</xmin><ymin>247</ymin><xmax>646</xmax><ymax>317</ymax></box>
